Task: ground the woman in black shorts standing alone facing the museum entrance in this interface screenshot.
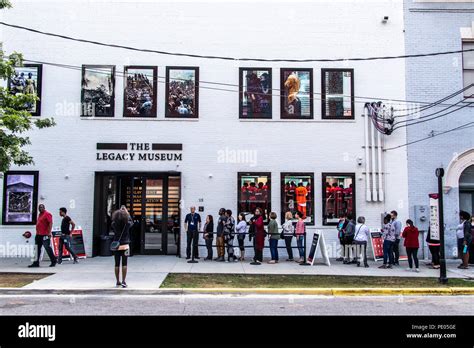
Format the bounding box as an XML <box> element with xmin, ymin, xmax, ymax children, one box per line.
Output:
<box><xmin>110</xmin><ymin>207</ymin><xmax>132</xmax><ymax>288</ymax></box>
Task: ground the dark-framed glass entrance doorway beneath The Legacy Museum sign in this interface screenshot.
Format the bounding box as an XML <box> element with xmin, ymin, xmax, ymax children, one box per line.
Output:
<box><xmin>93</xmin><ymin>172</ymin><xmax>181</xmax><ymax>256</ymax></box>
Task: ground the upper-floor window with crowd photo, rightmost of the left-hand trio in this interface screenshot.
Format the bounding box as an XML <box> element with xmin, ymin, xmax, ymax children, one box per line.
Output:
<box><xmin>165</xmin><ymin>67</ymin><xmax>199</xmax><ymax>118</ymax></box>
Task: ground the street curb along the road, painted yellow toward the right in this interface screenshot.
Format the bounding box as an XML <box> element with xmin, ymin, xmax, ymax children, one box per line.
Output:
<box><xmin>0</xmin><ymin>287</ymin><xmax>474</xmax><ymax>296</ymax></box>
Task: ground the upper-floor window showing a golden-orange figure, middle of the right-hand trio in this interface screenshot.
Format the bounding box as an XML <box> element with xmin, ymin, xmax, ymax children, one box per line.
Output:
<box><xmin>280</xmin><ymin>69</ymin><xmax>313</xmax><ymax>119</ymax></box>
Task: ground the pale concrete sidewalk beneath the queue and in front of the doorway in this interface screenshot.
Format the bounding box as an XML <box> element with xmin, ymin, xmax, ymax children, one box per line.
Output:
<box><xmin>0</xmin><ymin>255</ymin><xmax>474</xmax><ymax>291</ymax></box>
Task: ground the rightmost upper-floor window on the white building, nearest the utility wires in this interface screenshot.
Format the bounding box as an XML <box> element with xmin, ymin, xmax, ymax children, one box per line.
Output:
<box><xmin>321</xmin><ymin>69</ymin><xmax>354</xmax><ymax>120</ymax></box>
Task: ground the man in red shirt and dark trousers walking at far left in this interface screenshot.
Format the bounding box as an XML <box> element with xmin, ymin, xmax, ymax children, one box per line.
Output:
<box><xmin>28</xmin><ymin>204</ymin><xmax>57</xmax><ymax>267</ymax></box>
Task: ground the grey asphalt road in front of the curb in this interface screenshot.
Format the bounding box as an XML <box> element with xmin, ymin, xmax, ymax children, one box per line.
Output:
<box><xmin>0</xmin><ymin>294</ymin><xmax>474</xmax><ymax>316</ymax></box>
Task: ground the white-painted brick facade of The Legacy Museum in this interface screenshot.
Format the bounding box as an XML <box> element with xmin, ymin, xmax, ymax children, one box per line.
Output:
<box><xmin>0</xmin><ymin>0</ymin><xmax>408</xmax><ymax>255</ymax></box>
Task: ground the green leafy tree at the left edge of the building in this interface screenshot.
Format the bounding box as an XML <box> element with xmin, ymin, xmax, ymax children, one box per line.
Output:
<box><xmin>0</xmin><ymin>0</ymin><xmax>55</xmax><ymax>173</ymax></box>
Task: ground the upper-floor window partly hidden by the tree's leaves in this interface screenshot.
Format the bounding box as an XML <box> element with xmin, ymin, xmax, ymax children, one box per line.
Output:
<box><xmin>8</xmin><ymin>64</ymin><xmax>43</xmax><ymax>116</ymax></box>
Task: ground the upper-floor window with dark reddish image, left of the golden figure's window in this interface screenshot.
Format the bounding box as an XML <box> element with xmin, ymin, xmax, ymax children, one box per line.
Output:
<box><xmin>239</xmin><ymin>68</ymin><xmax>272</xmax><ymax>118</ymax></box>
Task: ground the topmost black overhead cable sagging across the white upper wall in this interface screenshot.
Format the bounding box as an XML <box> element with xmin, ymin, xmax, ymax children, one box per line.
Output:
<box><xmin>0</xmin><ymin>21</ymin><xmax>474</xmax><ymax>63</ymax></box>
